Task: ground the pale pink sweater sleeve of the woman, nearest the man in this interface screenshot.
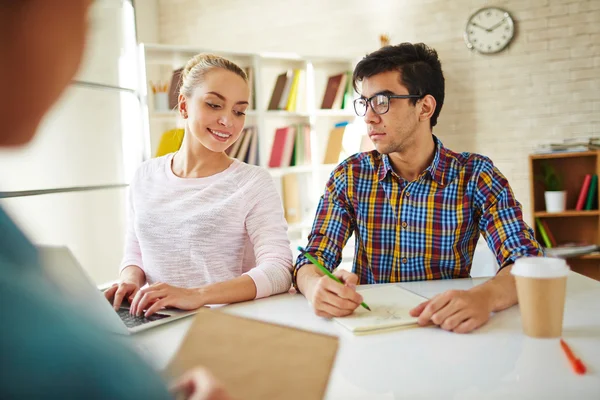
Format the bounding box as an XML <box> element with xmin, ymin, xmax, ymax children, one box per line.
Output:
<box><xmin>241</xmin><ymin>169</ymin><xmax>292</xmax><ymax>298</ymax></box>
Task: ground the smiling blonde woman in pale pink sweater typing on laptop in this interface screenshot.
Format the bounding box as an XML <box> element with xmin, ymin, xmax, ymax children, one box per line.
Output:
<box><xmin>106</xmin><ymin>54</ymin><xmax>292</xmax><ymax>316</ymax></box>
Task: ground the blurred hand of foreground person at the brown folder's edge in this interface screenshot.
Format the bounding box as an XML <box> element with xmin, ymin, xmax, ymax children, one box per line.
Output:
<box><xmin>170</xmin><ymin>367</ymin><xmax>231</xmax><ymax>400</ymax></box>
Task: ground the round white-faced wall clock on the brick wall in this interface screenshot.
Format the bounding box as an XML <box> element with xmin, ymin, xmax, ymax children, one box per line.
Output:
<box><xmin>465</xmin><ymin>7</ymin><xmax>515</xmax><ymax>54</ymax></box>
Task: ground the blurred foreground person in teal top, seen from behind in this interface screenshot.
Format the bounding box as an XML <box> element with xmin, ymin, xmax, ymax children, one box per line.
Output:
<box><xmin>0</xmin><ymin>0</ymin><xmax>228</xmax><ymax>400</ymax></box>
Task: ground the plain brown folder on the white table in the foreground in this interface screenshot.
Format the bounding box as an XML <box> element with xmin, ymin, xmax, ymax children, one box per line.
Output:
<box><xmin>166</xmin><ymin>309</ymin><xmax>338</xmax><ymax>400</ymax></box>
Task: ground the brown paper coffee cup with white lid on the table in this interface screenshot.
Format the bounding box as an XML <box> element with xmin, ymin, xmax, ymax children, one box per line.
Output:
<box><xmin>511</xmin><ymin>257</ymin><xmax>569</xmax><ymax>338</ymax></box>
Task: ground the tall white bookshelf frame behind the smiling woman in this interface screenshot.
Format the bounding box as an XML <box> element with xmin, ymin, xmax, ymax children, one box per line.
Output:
<box><xmin>139</xmin><ymin>43</ymin><xmax>358</xmax><ymax>253</ymax></box>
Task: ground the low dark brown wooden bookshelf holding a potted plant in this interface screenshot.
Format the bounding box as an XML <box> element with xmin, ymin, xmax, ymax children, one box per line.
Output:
<box><xmin>529</xmin><ymin>150</ymin><xmax>600</xmax><ymax>280</ymax></box>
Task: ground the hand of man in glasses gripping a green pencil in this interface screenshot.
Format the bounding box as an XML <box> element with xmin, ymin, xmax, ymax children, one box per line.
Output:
<box><xmin>305</xmin><ymin>267</ymin><xmax>363</xmax><ymax>318</ymax></box>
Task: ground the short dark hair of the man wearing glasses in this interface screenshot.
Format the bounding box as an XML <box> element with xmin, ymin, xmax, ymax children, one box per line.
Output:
<box><xmin>352</xmin><ymin>43</ymin><xmax>444</xmax><ymax>127</ymax></box>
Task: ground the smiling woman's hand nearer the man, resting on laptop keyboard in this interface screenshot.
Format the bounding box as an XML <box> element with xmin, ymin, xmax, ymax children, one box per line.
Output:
<box><xmin>129</xmin><ymin>283</ymin><xmax>205</xmax><ymax>317</ymax></box>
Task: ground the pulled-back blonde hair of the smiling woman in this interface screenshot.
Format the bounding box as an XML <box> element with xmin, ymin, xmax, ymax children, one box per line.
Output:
<box><xmin>179</xmin><ymin>53</ymin><xmax>248</xmax><ymax>97</ymax></box>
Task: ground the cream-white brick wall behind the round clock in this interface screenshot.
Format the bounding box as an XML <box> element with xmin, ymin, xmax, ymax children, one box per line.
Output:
<box><xmin>159</xmin><ymin>0</ymin><xmax>600</xmax><ymax>225</ymax></box>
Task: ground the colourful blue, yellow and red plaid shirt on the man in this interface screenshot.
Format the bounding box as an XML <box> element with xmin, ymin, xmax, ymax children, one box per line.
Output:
<box><xmin>294</xmin><ymin>136</ymin><xmax>543</xmax><ymax>284</ymax></box>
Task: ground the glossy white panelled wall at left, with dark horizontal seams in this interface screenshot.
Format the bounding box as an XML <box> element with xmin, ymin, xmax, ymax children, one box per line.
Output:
<box><xmin>0</xmin><ymin>0</ymin><xmax>141</xmax><ymax>283</ymax></box>
